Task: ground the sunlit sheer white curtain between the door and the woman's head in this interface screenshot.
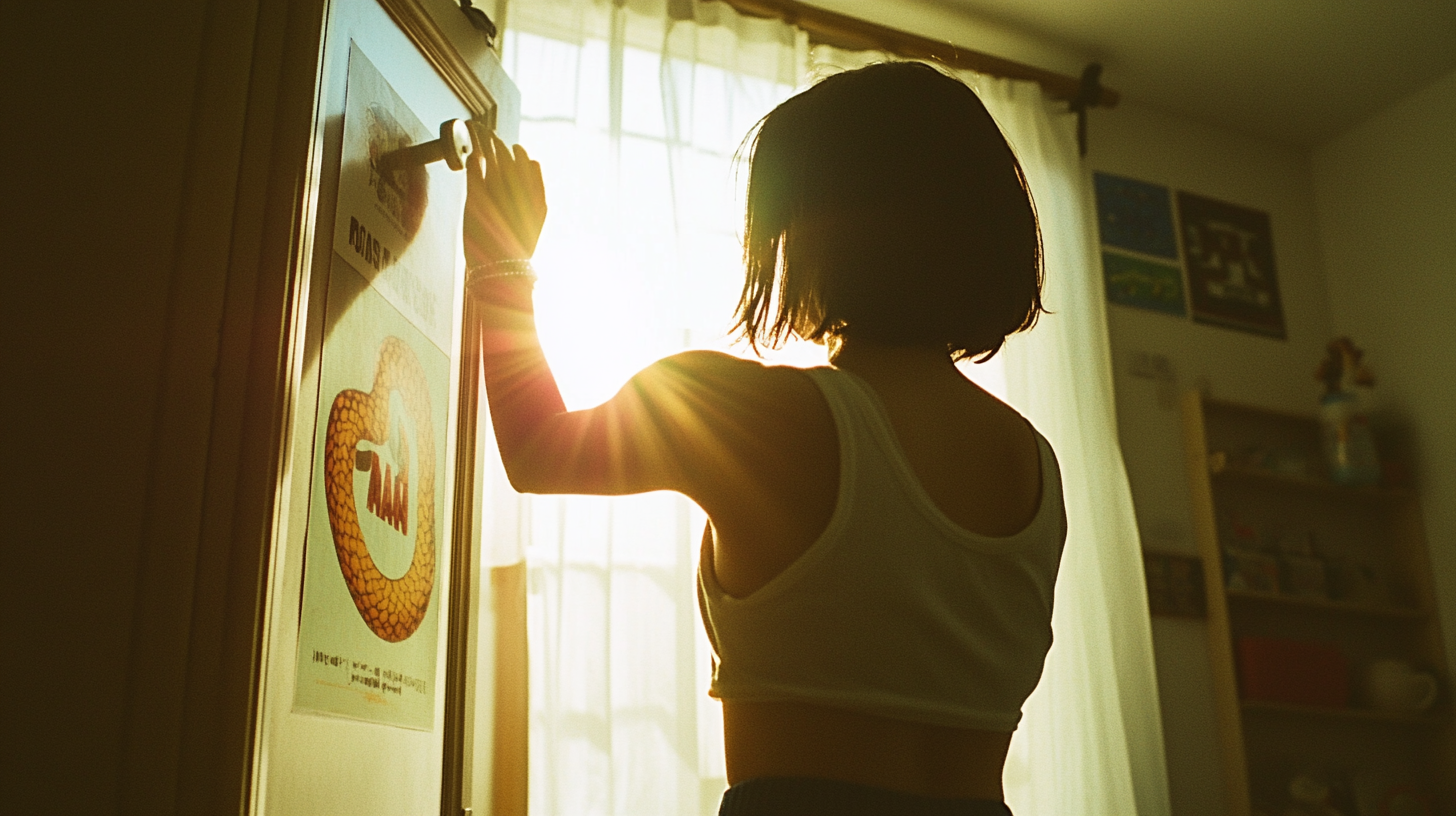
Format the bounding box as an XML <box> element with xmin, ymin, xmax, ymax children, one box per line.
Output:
<box><xmin>495</xmin><ymin>0</ymin><xmax>803</xmax><ymax>816</ymax></box>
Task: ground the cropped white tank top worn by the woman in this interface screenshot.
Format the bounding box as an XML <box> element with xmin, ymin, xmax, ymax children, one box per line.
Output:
<box><xmin>697</xmin><ymin>367</ymin><xmax>1067</xmax><ymax>731</ymax></box>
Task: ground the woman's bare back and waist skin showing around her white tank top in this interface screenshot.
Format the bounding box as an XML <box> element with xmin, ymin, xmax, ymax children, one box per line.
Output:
<box><xmin>705</xmin><ymin>340</ymin><xmax>1041</xmax><ymax>799</ymax></box>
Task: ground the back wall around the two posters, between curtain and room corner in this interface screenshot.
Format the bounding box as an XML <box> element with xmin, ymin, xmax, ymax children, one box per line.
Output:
<box><xmin>1086</xmin><ymin>103</ymin><xmax>1332</xmax><ymax>816</ymax></box>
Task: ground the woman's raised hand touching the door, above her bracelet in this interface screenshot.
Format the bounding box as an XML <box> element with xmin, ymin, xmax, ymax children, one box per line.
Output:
<box><xmin>464</xmin><ymin>122</ymin><xmax>546</xmax><ymax>267</ymax></box>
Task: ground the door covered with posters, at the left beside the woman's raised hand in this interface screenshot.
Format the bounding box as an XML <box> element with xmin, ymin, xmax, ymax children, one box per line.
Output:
<box><xmin>252</xmin><ymin>0</ymin><xmax>517</xmax><ymax>816</ymax></box>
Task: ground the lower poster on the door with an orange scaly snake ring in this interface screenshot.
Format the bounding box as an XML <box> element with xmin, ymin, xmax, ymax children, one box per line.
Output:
<box><xmin>294</xmin><ymin>255</ymin><xmax>450</xmax><ymax>730</ymax></box>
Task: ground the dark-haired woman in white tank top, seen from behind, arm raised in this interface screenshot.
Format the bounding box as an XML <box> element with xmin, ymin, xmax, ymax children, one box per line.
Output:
<box><xmin>464</xmin><ymin>63</ymin><xmax>1066</xmax><ymax>816</ymax></box>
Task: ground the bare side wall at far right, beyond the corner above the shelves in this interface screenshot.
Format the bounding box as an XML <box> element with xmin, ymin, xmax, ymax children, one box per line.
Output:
<box><xmin>1313</xmin><ymin>71</ymin><xmax>1456</xmax><ymax>676</ymax></box>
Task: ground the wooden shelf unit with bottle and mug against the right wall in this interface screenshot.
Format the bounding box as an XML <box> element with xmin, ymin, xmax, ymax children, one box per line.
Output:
<box><xmin>1182</xmin><ymin>392</ymin><xmax>1456</xmax><ymax>816</ymax></box>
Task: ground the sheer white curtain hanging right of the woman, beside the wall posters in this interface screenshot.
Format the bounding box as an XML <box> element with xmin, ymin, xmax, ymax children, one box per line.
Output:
<box><xmin>810</xmin><ymin>45</ymin><xmax>1171</xmax><ymax>816</ymax></box>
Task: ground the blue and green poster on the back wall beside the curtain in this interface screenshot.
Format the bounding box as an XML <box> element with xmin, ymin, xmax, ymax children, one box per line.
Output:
<box><xmin>1092</xmin><ymin>173</ymin><xmax>1188</xmax><ymax>318</ymax></box>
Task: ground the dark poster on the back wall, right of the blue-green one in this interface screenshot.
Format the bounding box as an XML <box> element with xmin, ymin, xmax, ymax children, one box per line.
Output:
<box><xmin>1178</xmin><ymin>191</ymin><xmax>1286</xmax><ymax>340</ymax></box>
